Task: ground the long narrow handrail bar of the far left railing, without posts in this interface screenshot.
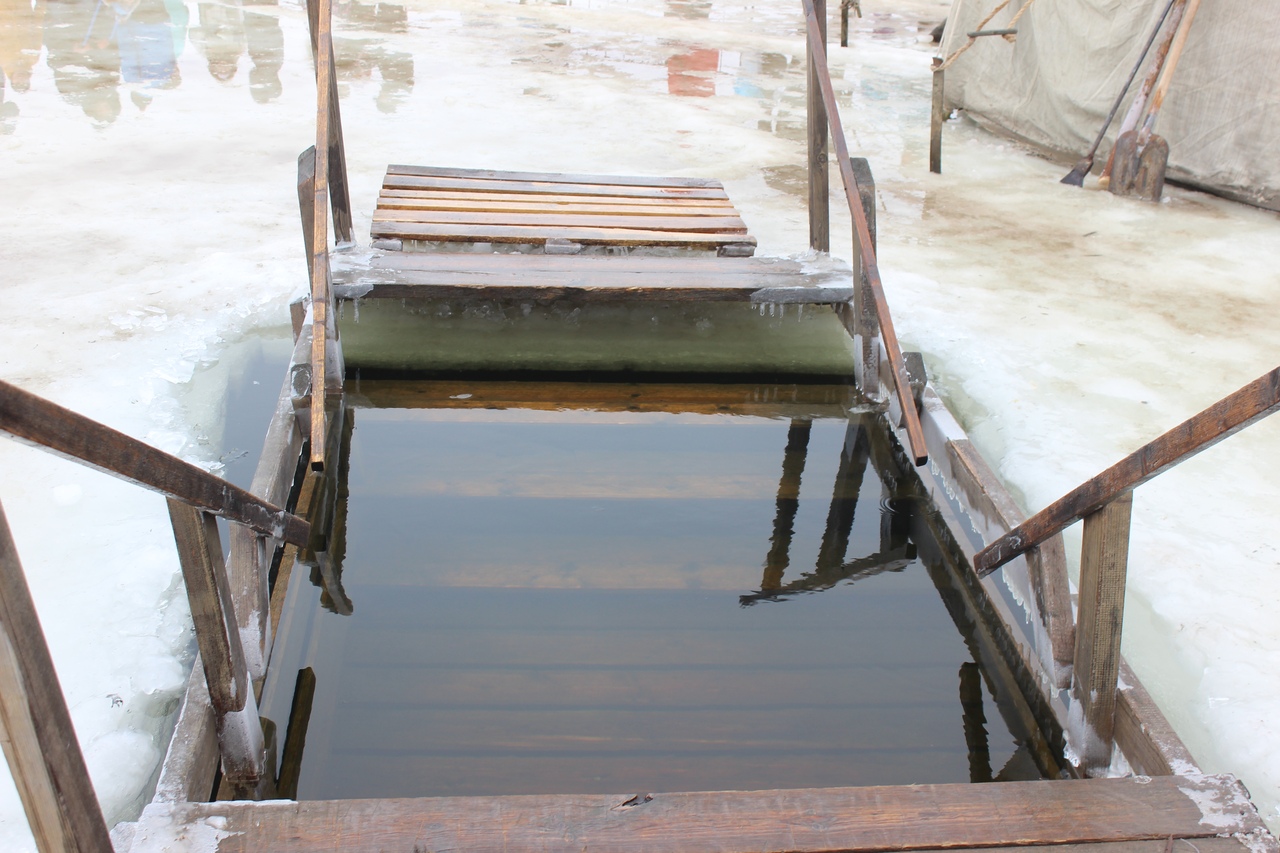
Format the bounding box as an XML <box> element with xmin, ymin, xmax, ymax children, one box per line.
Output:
<box><xmin>311</xmin><ymin>0</ymin><xmax>334</xmax><ymax>471</ymax></box>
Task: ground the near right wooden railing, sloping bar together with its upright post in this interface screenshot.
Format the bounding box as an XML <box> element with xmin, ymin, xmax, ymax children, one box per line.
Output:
<box><xmin>974</xmin><ymin>368</ymin><xmax>1280</xmax><ymax>771</ymax></box>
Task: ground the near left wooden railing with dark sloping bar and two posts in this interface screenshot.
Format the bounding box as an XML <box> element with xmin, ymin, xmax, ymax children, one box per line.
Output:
<box><xmin>0</xmin><ymin>382</ymin><xmax>311</xmax><ymax>853</ymax></box>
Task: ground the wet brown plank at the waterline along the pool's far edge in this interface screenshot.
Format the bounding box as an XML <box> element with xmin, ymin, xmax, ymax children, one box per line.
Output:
<box><xmin>347</xmin><ymin>379</ymin><xmax>858</xmax><ymax>418</ymax></box>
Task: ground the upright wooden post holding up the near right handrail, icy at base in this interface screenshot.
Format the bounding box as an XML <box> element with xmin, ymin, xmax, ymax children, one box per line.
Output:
<box><xmin>1075</xmin><ymin>492</ymin><xmax>1133</xmax><ymax>776</ymax></box>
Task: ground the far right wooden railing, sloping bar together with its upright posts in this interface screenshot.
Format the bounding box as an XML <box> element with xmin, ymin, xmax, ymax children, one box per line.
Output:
<box><xmin>801</xmin><ymin>0</ymin><xmax>929</xmax><ymax>465</ymax></box>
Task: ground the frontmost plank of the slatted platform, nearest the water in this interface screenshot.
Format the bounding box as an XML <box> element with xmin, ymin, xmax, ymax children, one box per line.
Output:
<box><xmin>371</xmin><ymin>222</ymin><xmax>755</xmax><ymax>248</ymax></box>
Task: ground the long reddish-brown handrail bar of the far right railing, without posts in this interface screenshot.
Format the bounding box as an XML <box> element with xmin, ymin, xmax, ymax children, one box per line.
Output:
<box><xmin>801</xmin><ymin>0</ymin><xmax>929</xmax><ymax>465</ymax></box>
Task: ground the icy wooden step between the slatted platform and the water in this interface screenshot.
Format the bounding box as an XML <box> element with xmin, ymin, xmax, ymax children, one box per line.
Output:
<box><xmin>333</xmin><ymin>251</ymin><xmax>854</xmax><ymax>305</ymax></box>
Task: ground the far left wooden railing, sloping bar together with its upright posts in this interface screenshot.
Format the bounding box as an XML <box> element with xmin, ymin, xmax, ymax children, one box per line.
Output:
<box><xmin>298</xmin><ymin>0</ymin><xmax>352</xmax><ymax>471</ymax></box>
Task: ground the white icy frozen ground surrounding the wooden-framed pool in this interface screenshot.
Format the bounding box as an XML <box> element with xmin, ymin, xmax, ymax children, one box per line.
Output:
<box><xmin>0</xmin><ymin>0</ymin><xmax>1280</xmax><ymax>850</ymax></box>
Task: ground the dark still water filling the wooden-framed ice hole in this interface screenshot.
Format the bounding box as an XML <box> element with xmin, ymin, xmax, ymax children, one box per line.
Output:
<box><xmin>262</xmin><ymin>384</ymin><xmax>1042</xmax><ymax>799</ymax></box>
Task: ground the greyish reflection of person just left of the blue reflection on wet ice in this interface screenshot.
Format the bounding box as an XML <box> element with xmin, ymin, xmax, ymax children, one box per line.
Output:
<box><xmin>45</xmin><ymin>0</ymin><xmax>120</xmax><ymax>124</ymax></box>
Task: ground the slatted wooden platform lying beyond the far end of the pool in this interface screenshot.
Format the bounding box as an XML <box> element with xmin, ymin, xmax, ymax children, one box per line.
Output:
<box><xmin>372</xmin><ymin>165</ymin><xmax>755</xmax><ymax>257</ymax></box>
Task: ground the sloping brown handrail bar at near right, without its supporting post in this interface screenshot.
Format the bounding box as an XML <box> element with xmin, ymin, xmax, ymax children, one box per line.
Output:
<box><xmin>974</xmin><ymin>368</ymin><xmax>1280</xmax><ymax>575</ymax></box>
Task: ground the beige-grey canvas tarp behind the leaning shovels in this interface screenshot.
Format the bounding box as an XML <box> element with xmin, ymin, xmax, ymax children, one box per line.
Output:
<box><xmin>941</xmin><ymin>0</ymin><xmax>1280</xmax><ymax>209</ymax></box>
